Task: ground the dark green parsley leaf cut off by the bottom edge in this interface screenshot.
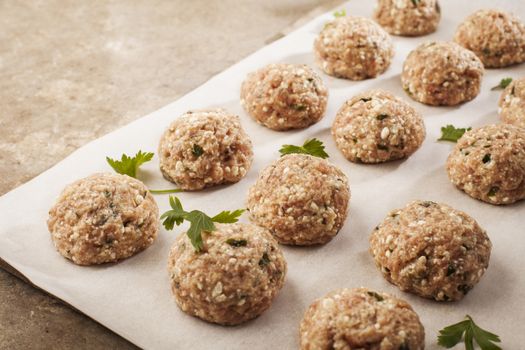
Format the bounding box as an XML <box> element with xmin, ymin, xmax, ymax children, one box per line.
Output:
<box><xmin>438</xmin><ymin>315</ymin><xmax>501</xmax><ymax>350</ymax></box>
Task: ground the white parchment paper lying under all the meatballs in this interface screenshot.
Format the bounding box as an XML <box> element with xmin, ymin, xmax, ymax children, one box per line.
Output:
<box><xmin>0</xmin><ymin>0</ymin><xmax>525</xmax><ymax>349</ymax></box>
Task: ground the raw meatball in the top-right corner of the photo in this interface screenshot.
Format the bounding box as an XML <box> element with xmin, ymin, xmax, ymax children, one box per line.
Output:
<box><xmin>454</xmin><ymin>10</ymin><xmax>525</xmax><ymax>68</ymax></box>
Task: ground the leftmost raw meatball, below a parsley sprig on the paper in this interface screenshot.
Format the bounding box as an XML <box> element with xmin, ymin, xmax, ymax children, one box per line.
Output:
<box><xmin>47</xmin><ymin>173</ymin><xmax>159</xmax><ymax>265</ymax></box>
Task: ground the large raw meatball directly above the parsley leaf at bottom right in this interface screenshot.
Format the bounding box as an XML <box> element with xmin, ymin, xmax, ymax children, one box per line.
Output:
<box><xmin>370</xmin><ymin>201</ymin><xmax>492</xmax><ymax>301</ymax></box>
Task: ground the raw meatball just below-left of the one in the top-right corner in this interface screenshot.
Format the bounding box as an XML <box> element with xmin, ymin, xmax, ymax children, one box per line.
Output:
<box><xmin>401</xmin><ymin>42</ymin><xmax>484</xmax><ymax>106</ymax></box>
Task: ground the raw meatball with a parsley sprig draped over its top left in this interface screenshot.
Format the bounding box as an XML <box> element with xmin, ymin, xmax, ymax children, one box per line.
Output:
<box><xmin>168</xmin><ymin>223</ymin><xmax>286</xmax><ymax>325</ymax></box>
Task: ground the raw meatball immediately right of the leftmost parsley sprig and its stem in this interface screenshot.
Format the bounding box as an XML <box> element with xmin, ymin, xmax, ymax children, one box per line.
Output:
<box><xmin>159</xmin><ymin>109</ymin><xmax>253</xmax><ymax>190</ymax></box>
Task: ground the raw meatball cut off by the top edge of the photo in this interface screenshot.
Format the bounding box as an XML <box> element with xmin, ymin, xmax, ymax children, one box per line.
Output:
<box><xmin>374</xmin><ymin>0</ymin><xmax>441</xmax><ymax>36</ymax></box>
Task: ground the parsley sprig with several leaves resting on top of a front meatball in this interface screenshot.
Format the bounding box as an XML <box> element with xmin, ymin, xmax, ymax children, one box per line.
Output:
<box><xmin>160</xmin><ymin>196</ymin><xmax>244</xmax><ymax>252</ymax></box>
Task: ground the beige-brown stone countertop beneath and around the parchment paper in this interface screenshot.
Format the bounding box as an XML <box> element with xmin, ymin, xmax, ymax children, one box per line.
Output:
<box><xmin>0</xmin><ymin>0</ymin><xmax>343</xmax><ymax>349</ymax></box>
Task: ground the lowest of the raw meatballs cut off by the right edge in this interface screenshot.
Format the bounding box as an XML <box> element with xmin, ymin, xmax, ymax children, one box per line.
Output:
<box><xmin>447</xmin><ymin>124</ymin><xmax>525</xmax><ymax>204</ymax></box>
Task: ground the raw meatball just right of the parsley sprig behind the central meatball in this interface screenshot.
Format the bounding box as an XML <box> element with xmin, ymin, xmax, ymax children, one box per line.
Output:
<box><xmin>332</xmin><ymin>90</ymin><xmax>426</xmax><ymax>163</ymax></box>
